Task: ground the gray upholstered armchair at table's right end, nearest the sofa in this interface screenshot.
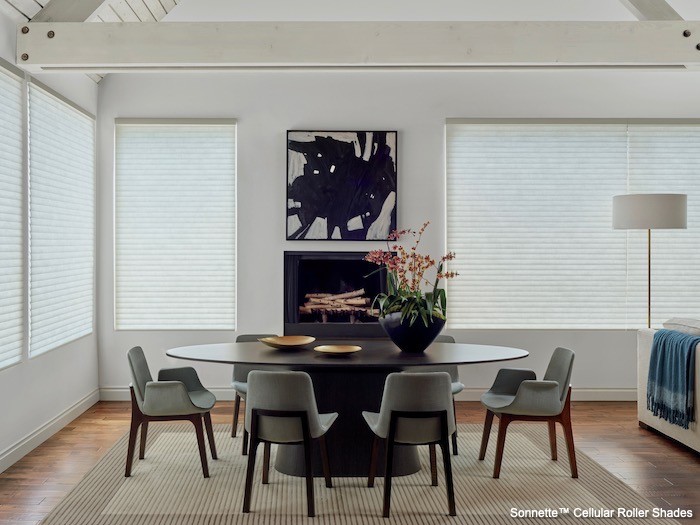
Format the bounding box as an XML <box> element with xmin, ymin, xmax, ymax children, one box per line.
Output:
<box><xmin>479</xmin><ymin>348</ymin><xmax>578</xmax><ymax>478</ymax></box>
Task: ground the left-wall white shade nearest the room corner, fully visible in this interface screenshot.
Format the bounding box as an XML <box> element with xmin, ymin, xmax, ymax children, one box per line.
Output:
<box><xmin>29</xmin><ymin>84</ymin><xmax>95</xmax><ymax>356</ymax></box>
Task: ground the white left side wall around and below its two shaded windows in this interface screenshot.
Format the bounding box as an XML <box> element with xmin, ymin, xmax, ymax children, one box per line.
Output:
<box><xmin>0</xmin><ymin>13</ymin><xmax>98</xmax><ymax>472</ymax></box>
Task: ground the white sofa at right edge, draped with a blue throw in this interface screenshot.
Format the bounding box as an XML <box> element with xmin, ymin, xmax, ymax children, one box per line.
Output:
<box><xmin>637</xmin><ymin>328</ymin><xmax>700</xmax><ymax>452</ymax></box>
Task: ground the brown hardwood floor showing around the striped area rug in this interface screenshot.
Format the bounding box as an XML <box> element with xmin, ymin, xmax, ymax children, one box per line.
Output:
<box><xmin>0</xmin><ymin>402</ymin><xmax>700</xmax><ymax>524</ymax></box>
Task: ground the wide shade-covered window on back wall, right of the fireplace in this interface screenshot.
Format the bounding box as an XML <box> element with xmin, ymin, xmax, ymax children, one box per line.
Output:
<box><xmin>446</xmin><ymin>122</ymin><xmax>700</xmax><ymax>328</ymax></box>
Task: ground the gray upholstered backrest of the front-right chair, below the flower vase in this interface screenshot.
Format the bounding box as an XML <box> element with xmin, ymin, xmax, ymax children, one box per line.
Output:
<box><xmin>378</xmin><ymin>372</ymin><xmax>455</xmax><ymax>444</ymax></box>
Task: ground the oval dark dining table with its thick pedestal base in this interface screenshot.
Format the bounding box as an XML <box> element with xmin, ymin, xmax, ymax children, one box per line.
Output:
<box><xmin>166</xmin><ymin>339</ymin><xmax>529</xmax><ymax>477</ymax></box>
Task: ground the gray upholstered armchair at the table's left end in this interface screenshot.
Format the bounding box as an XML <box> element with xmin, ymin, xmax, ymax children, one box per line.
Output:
<box><xmin>125</xmin><ymin>346</ymin><xmax>217</xmax><ymax>478</ymax></box>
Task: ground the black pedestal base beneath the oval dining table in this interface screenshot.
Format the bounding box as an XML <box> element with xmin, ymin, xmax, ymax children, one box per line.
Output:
<box><xmin>275</xmin><ymin>366</ymin><xmax>420</xmax><ymax>477</ymax></box>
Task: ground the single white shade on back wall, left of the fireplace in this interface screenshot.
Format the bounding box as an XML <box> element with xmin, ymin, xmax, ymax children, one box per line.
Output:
<box><xmin>115</xmin><ymin>122</ymin><xmax>236</xmax><ymax>330</ymax></box>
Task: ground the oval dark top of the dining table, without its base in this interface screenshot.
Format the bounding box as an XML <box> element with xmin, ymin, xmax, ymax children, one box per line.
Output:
<box><xmin>166</xmin><ymin>339</ymin><xmax>529</xmax><ymax>368</ymax></box>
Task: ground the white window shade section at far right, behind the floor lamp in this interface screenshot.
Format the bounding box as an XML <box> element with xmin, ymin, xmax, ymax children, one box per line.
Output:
<box><xmin>627</xmin><ymin>124</ymin><xmax>700</xmax><ymax>326</ymax></box>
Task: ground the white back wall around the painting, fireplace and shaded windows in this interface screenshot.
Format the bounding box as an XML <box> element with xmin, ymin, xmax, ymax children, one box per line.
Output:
<box><xmin>98</xmin><ymin>66</ymin><xmax>700</xmax><ymax>399</ymax></box>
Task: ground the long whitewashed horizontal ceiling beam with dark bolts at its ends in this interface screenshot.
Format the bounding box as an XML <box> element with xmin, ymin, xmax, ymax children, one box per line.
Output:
<box><xmin>17</xmin><ymin>21</ymin><xmax>700</xmax><ymax>73</ymax></box>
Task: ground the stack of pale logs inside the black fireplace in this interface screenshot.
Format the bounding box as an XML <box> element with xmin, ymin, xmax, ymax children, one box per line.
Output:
<box><xmin>299</xmin><ymin>288</ymin><xmax>379</xmax><ymax>323</ymax></box>
